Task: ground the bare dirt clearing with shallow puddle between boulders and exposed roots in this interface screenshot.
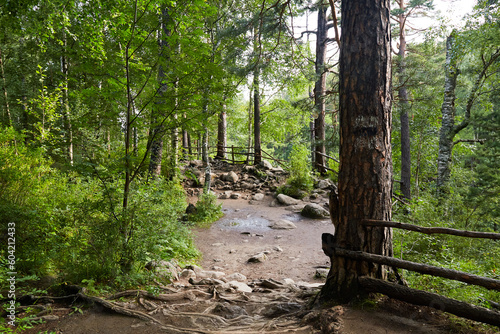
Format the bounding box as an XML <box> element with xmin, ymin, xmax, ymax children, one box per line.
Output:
<box><xmin>195</xmin><ymin>196</ymin><xmax>333</xmax><ymax>283</ymax></box>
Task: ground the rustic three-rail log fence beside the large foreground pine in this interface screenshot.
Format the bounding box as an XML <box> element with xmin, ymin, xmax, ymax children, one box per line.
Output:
<box><xmin>323</xmin><ymin>219</ymin><xmax>500</xmax><ymax>327</ymax></box>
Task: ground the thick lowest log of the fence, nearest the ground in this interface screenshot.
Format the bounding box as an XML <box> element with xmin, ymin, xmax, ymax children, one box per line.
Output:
<box><xmin>358</xmin><ymin>276</ymin><xmax>500</xmax><ymax>327</ymax></box>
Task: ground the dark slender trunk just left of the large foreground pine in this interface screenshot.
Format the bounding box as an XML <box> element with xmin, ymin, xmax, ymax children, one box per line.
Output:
<box><xmin>314</xmin><ymin>3</ymin><xmax>328</xmax><ymax>175</ymax></box>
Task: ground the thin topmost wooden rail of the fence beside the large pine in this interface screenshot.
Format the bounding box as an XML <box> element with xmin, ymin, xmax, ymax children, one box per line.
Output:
<box><xmin>361</xmin><ymin>219</ymin><xmax>500</xmax><ymax>240</ymax></box>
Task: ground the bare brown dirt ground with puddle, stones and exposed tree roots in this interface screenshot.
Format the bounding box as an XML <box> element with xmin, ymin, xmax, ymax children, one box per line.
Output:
<box><xmin>18</xmin><ymin>160</ymin><xmax>498</xmax><ymax>334</ymax></box>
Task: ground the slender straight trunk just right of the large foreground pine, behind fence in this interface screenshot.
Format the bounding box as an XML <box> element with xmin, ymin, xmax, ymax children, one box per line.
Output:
<box><xmin>398</xmin><ymin>0</ymin><xmax>411</xmax><ymax>199</ymax></box>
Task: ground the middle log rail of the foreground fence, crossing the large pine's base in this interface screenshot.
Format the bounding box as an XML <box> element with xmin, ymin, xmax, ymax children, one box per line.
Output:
<box><xmin>333</xmin><ymin>248</ymin><xmax>500</xmax><ymax>291</ymax></box>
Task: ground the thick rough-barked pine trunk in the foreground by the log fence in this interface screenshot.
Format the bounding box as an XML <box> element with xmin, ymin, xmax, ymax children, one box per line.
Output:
<box><xmin>320</xmin><ymin>0</ymin><xmax>392</xmax><ymax>302</ymax></box>
